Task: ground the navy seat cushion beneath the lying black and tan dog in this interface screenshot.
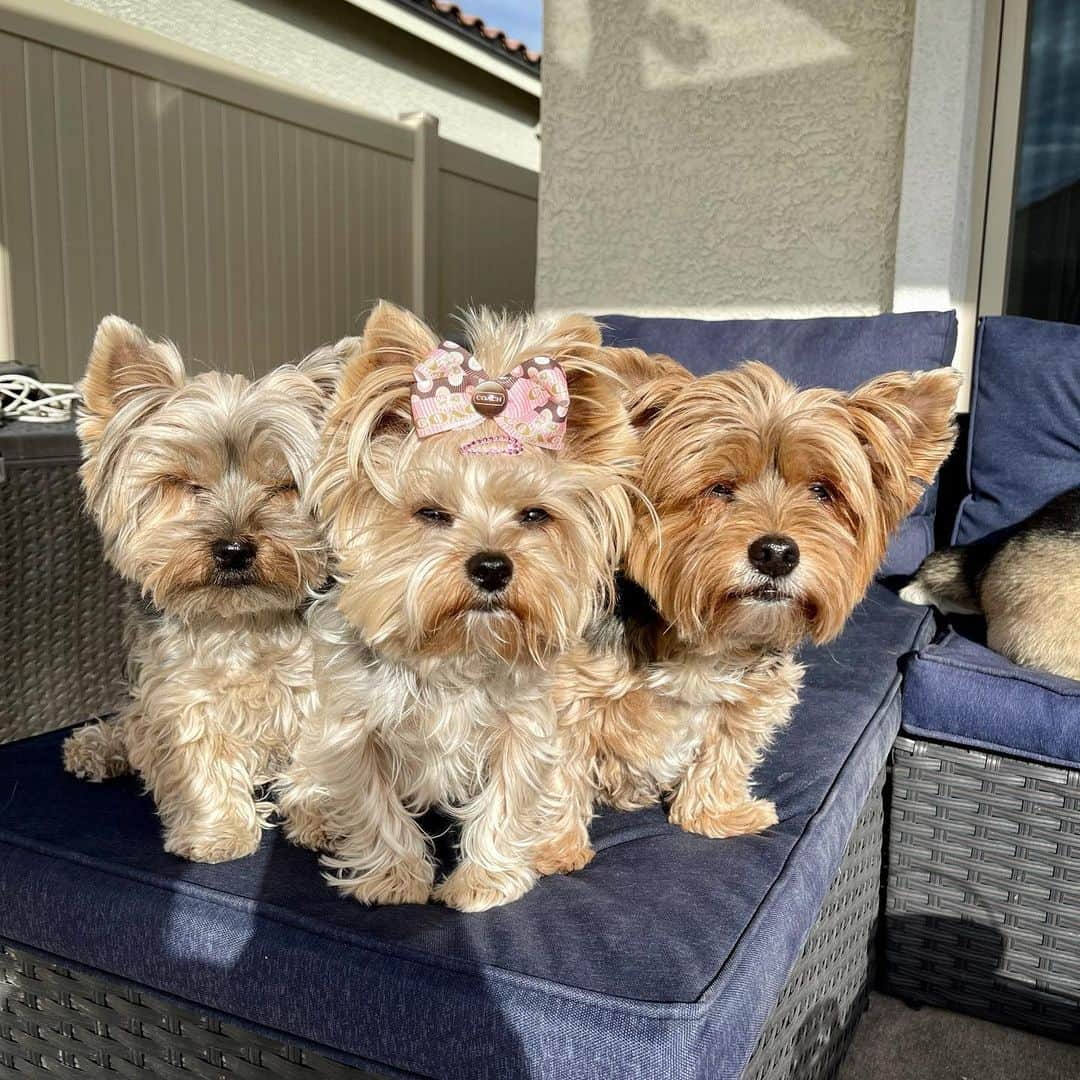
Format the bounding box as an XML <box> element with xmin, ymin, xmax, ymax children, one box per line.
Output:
<box><xmin>904</xmin><ymin>626</ymin><xmax>1080</xmax><ymax>769</ymax></box>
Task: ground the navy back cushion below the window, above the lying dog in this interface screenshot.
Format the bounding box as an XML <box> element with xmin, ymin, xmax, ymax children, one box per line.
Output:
<box><xmin>954</xmin><ymin>315</ymin><xmax>1080</xmax><ymax>544</ymax></box>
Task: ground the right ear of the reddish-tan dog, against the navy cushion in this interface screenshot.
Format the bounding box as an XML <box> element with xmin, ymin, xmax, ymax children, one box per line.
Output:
<box><xmin>847</xmin><ymin>367</ymin><xmax>961</xmax><ymax>530</ymax></box>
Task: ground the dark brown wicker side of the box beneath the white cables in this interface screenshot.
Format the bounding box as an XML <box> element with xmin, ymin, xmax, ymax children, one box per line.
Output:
<box><xmin>0</xmin><ymin>461</ymin><xmax>124</xmax><ymax>742</ymax></box>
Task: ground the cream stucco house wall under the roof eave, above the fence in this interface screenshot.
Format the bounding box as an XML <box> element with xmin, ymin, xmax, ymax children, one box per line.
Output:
<box><xmin>69</xmin><ymin>0</ymin><xmax>540</xmax><ymax>168</ymax></box>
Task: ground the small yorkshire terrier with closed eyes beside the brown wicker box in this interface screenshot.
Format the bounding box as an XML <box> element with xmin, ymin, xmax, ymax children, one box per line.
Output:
<box><xmin>64</xmin><ymin>316</ymin><xmax>339</xmax><ymax>863</ymax></box>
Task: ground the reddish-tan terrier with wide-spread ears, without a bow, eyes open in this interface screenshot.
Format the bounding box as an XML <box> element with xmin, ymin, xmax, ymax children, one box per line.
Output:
<box><xmin>544</xmin><ymin>358</ymin><xmax>958</xmax><ymax>869</ymax></box>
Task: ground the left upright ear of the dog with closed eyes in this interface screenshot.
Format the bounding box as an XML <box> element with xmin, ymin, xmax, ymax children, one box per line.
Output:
<box><xmin>79</xmin><ymin>315</ymin><xmax>186</xmax><ymax>447</ymax></box>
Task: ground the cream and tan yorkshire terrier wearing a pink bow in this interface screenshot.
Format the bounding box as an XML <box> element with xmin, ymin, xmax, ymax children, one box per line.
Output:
<box><xmin>279</xmin><ymin>303</ymin><xmax>637</xmax><ymax>910</ymax></box>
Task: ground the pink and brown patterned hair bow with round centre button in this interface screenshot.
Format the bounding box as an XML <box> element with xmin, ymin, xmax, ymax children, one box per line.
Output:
<box><xmin>411</xmin><ymin>341</ymin><xmax>570</xmax><ymax>454</ymax></box>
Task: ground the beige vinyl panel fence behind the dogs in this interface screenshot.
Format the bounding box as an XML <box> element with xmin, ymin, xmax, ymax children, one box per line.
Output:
<box><xmin>0</xmin><ymin>0</ymin><xmax>537</xmax><ymax>381</ymax></box>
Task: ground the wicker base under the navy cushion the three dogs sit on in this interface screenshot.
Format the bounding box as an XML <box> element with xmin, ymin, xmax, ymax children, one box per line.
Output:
<box><xmin>0</xmin><ymin>778</ymin><xmax>882</xmax><ymax>1080</ymax></box>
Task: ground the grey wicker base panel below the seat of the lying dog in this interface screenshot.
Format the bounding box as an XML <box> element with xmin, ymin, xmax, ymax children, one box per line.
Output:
<box><xmin>886</xmin><ymin>738</ymin><xmax>1080</xmax><ymax>1042</ymax></box>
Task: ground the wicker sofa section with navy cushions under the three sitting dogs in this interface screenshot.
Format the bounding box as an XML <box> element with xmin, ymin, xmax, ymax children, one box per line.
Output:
<box><xmin>0</xmin><ymin>313</ymin><xmax>955</xmax><ymax>1080</ymax></box>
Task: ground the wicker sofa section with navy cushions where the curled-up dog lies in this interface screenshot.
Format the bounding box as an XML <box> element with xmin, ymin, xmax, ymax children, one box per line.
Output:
<box><xmin>886</xmin><ymin>318</ymin><xmax>1080</xmax><ymax>1041</ymax></box>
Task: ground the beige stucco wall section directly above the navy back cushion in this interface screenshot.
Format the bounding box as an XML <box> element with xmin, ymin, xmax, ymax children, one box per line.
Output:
<box><xmin>537</xmin><ymin>0</ymin><xmax>914</xmax><ymax>315</ymax></box>
